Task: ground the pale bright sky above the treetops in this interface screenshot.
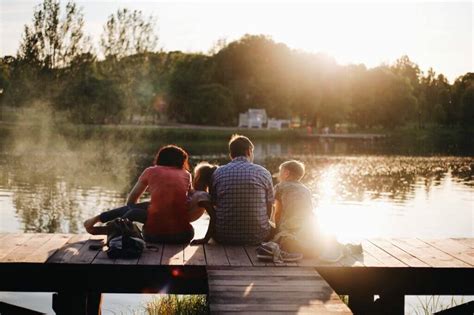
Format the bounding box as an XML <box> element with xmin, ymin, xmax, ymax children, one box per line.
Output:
<box><xmin>0</xmin><ymin>0</ymin><xmax>473</xmax><ymax>82</ymax></box>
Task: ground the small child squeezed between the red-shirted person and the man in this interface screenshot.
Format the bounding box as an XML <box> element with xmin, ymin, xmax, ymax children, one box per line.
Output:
<box><xmin>188</xmin><ymin>162</ymin><xmax>218</xmax><ymax>245</ymax></box>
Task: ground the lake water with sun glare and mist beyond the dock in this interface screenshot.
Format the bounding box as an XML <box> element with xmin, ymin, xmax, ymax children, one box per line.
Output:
<box><xmin>0</xmin><ymin>127</ymin><xmax>474</xmax><ymax>312</ymax></box>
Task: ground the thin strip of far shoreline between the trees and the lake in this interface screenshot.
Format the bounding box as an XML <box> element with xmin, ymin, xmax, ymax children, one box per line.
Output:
<box><xmin>0</xmin><ymin>121</ymin><xmax>474</xmax><ymax>141</ymax></box>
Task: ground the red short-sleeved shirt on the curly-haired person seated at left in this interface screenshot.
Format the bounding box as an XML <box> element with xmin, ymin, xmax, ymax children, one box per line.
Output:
<box><xmin>139</xmin><ymin>165</ymin><xmax>192</xmax><ymax>236</ymax></box>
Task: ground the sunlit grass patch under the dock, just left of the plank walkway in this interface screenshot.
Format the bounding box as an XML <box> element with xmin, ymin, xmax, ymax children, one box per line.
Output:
<box><xmin>145</xmin><ymin>294</ymin><xmax>209</xmax><ymax>315</ymax></box>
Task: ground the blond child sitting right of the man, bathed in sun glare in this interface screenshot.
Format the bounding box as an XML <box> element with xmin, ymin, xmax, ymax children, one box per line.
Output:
<box><xmin>273</xmin><ymin>160</ymin><xmax>362</xmax><ymax>262</ymax></box>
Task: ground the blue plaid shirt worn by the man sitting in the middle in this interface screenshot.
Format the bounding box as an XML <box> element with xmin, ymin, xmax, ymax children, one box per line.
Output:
<box><xmin>211</xmin><ymin>156</ymin><xmax>274</xmax><ymax>244</ymax></box>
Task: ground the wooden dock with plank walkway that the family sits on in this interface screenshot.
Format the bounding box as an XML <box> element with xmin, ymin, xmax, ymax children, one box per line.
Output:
<box><xmin>0</xmin><ymin>234</ymin><xmax>474</xmax><ymax>314</ymax></box>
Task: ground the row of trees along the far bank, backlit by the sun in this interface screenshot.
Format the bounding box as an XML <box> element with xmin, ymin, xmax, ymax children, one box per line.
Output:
<box><xmin>0</xmin><ymin>0</ymin><xmax>474</xmax><ymax>128</ymax></box>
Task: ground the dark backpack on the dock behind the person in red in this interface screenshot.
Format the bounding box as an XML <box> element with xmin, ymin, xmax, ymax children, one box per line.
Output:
<box><xmin>107</xmin><ymin>218</ymin><xmax>145</xmax><ymax>259</ymax></box>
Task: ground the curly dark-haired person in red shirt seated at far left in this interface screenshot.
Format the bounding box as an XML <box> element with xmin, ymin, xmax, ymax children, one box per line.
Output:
<box><xmin>84</xmin><ymin>145</ymin><xmax>194</xmax><ymax>243</ymax></box>
